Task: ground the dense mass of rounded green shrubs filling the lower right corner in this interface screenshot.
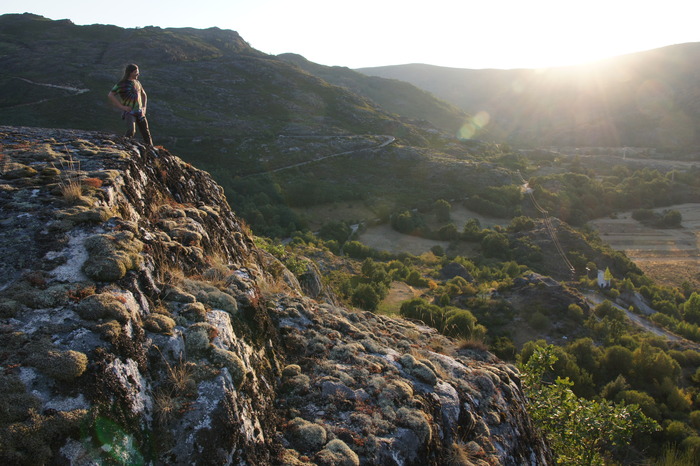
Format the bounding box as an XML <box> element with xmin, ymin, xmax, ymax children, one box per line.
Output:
<box><xmin>519</xmin><ymin>302</ymin><xmax>700</xmax><ymax>461</ymax></box>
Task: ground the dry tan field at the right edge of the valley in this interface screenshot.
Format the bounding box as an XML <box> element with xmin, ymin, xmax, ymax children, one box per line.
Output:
<box><xmin>590</xmin><ymin>204</ymin><xmax>700</xmax><ymax>288</ymax></box>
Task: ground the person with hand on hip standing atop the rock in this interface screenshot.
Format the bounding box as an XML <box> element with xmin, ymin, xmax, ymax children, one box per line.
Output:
<box><xmin>107</xmin><ymin>63</ymin><xmax>153</xmax><ymax>147</ymax></box>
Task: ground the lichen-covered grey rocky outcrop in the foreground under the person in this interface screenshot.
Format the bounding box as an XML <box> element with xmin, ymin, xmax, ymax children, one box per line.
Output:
<box><xmin>0</xmin><ymin>127</ymin><xmax>552</xmax><ymax>465</ymax></box>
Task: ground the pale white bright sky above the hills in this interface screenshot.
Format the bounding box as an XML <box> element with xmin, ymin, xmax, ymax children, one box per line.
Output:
<box><xmin>5</xmin><ymin>0</ymin><xmax>700</xmax><ymax>69</ymax></box>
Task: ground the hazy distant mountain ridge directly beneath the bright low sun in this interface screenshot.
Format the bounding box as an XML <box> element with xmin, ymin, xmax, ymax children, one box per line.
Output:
<box><xmin>356</xmin><ymin>43</ymin><xmax>700</xmax><ymax>148</ymax></box>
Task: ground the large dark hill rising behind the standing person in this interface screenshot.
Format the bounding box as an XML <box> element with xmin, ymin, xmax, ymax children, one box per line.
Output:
<box><xmin>0</xmin><ymin>14</ymin><xmax>508</xmax><ymax>236</ymax></box>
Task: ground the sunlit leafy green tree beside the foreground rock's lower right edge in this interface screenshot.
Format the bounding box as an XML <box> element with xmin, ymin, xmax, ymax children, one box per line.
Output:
<box><xmin>520</xmin><ymin>345</ymin><xmax>659</xmax><ymax>465</ymax></box>
